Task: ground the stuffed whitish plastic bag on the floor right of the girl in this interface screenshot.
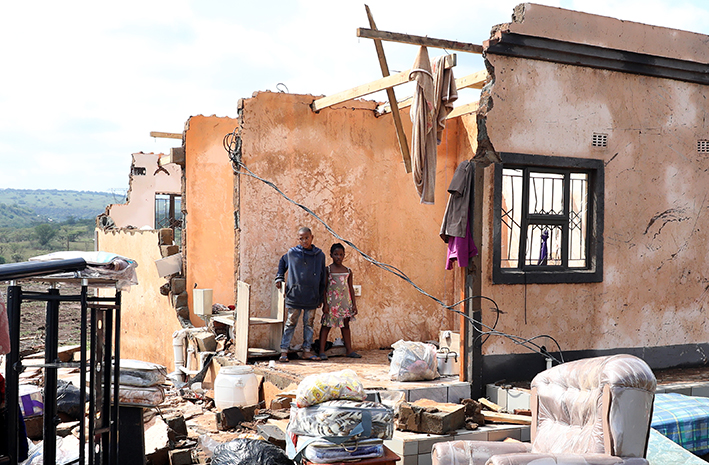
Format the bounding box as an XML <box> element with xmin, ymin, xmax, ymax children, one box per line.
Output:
<box><xmin>389</xmin><ymin>339</ymin><xmax>438</xmax><ymax>381</ymax></box>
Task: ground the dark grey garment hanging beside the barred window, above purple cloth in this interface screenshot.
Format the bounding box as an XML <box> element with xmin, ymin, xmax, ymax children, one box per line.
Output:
<box><xmin>440</xmin><ymin>160</ymin><xmax>475</xmax><ymax>242</ymax></box>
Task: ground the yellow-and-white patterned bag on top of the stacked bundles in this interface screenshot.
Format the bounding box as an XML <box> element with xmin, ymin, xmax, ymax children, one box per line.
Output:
<box><xmin>295</xmin><ymin>369</ymin><xmax>367</xmax><ymax>407</ymax></box>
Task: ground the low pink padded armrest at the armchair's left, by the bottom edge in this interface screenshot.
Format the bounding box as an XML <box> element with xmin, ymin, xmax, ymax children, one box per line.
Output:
<box><xmin>431</xmin><ymin>441</ymin><xmax>532</xmax><ymax>465</ymax></box>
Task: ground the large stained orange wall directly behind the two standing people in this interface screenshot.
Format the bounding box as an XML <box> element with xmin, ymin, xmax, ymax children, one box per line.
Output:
<box><xmin>235</xmin><ymin>92</ymin><xmax>459</xmax><ymax>349</ymax></box>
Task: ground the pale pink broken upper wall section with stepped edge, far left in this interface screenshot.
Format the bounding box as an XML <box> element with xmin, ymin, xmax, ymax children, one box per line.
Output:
<box><xmin>107</xmin><ymin>152</ymin><xmax>182</xmax><ymax>229</ymax></box>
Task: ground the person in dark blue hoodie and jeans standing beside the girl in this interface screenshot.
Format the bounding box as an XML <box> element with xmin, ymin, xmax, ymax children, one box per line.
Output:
<box><xmin>276</xmin><ymin>227</ymin><xmax>327</xmax><ymax>362</ymax></box>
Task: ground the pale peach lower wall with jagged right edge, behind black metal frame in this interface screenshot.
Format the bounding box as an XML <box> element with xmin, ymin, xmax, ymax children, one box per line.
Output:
<box><xmin>96</xmin><ymin>229</ymin><xmax>181</xmax><ymax>371</ymax></box>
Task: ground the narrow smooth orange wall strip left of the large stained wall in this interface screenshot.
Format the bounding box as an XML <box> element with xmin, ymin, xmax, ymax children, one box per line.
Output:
<box><xmin>183</xmin><ymin>115</ymin><xmax>237</xmax><ymax>320</ymax></box>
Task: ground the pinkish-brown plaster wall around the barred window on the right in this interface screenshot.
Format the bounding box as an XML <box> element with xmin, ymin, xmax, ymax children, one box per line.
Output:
<box><xmin>482</xmin><ymin>16</ymin><xmax>709</xmax><ymax>354</ymax></box>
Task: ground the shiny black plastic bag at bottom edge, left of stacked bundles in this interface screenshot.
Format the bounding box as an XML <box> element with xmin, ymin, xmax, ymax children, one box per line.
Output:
<box><xmin>212</xmin><ymin>439</ymin><xmax>295</xmax><ymax>465</ymax></box>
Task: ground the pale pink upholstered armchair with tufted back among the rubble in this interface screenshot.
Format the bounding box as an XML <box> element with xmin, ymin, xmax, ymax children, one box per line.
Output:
<box><xmin>431</xmin><ymin>355</ymin><xmax>657</xmax><ymax>465</ymax></box>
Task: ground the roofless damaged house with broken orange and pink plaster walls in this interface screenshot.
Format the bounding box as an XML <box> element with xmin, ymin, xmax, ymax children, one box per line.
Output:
<box><xmin>97</xmin><ymin>4</ymin><xmax>709</xmax><ymax>395</ymax></box>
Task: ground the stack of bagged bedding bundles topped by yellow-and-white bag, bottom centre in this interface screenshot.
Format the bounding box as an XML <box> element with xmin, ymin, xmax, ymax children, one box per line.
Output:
<box><xmin>286</xmin><ymin>369</ymin><xmax>394</xmax><ymax>463</ymax></box>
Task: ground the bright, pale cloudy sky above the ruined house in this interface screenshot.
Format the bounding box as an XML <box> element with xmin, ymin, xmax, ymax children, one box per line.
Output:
<box><xmin>0</xmin><ymin>0</ymin><xmax>709</xmax><ymax>191</ymax></box>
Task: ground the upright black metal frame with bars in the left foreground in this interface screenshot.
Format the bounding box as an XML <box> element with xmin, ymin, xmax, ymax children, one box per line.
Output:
<box><xmin>0</xmin><ymin>259</ymin><xmax>121</xmax><ymax>465</ymax></box>
